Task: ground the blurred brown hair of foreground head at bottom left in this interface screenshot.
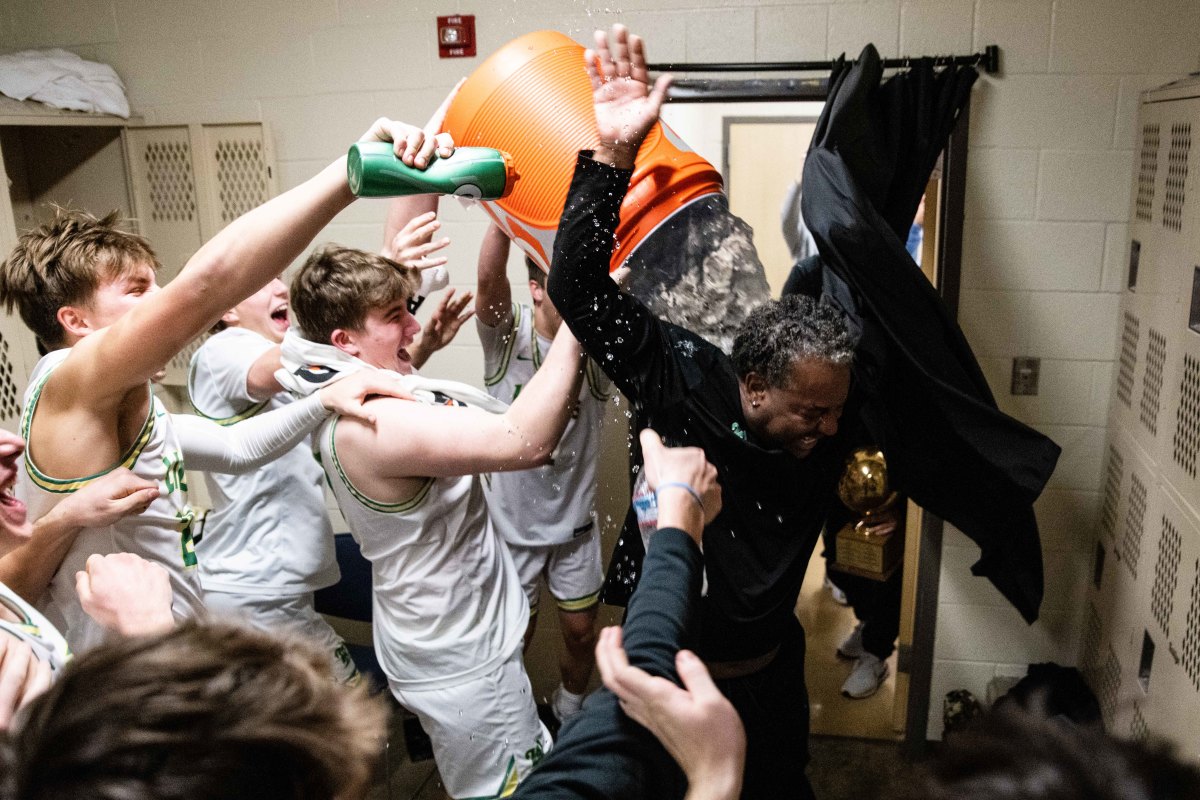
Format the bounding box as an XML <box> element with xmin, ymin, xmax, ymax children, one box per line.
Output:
<box><xmin>2</xmin><ymin>622</ymin><xmax>386</xmax><ymax>800</ymax></box>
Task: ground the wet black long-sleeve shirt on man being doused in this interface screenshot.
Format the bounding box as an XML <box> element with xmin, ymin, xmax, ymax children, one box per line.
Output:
<box><xmin>548</xmin><ymin>154</ymin><xmax>841</xmax><ymax>661</ymax></box>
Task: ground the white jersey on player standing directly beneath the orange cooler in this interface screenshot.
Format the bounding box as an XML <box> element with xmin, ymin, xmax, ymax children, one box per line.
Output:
<box><xmin>476</xmin><ymin>303</ymin><xmax>612</xmax><ymax>546</ymax></box>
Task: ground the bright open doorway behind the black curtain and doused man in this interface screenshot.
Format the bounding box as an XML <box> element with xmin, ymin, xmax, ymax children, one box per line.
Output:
<box><xmin>662</xmin><ymin>101</ymin><xmax>961</xmax><ymax>744</ymax></box>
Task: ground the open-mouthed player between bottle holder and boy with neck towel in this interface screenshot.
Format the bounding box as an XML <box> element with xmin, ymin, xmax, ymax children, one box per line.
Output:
<box><xmin>187</xmin><ymin>205</ymin><xmax>472</xmax><ymax>682</ymax></box>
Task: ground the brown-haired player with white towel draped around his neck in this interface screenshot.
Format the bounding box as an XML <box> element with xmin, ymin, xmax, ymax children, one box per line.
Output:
<box><xmin>282</xmin><ymin>246</ymin><xmax>582</xmax><ymax>798</ymax></box>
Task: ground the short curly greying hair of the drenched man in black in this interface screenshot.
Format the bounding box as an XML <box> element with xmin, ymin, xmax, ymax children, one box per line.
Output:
<box><xmin>731</xmin><ymin>295</ymin><xmax>858</xmax><ymax>386</ymax></box>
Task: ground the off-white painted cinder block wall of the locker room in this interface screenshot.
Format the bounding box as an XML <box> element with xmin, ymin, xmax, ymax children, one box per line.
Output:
<box><xmin>0</xmin><ymin>0</ymin><xmax>1200</xmax><ymax>735</ymax></box>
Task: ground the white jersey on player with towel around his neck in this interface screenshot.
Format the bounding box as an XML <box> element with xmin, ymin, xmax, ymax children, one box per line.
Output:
<box><xmin>319</xmin><ymin>417</ymin><xmax>529</xmax><ymax>691</ymax></box>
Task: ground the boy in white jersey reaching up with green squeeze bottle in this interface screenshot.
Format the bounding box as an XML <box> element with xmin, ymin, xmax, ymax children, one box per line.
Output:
<box><xmin>0</xmin><ymin>112</ymin><xmax>452</xmax><ymax>648</ymax></box>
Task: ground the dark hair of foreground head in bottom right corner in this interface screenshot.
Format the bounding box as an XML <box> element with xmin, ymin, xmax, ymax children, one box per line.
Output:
<box><xmin>910</xmin><ymin>704</ymin><xmax>1200</xmax><ymax>800</ymax></box>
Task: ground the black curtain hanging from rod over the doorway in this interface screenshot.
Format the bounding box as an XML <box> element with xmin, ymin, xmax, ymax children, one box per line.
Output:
<box><xmin>785</xmin><ymin>44</ymin><xmax>1060</xmax><ymax>622</ymax></box>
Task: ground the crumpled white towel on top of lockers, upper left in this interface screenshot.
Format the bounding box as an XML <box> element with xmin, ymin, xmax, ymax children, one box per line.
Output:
<box><xmin>0</xmin><ymin>48</ymin><xmax>130</xmax><ymax>119</ymax></box>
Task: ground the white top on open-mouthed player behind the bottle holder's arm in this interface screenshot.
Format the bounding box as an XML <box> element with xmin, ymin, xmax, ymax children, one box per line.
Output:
<box><xmin>187</xmin><ymin>327</ymin><xmax>338</xmax><ymax>595</ymax></box>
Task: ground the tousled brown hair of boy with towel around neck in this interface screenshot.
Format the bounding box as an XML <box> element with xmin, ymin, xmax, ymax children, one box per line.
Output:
<box><xmin>288</xmin><ymin>245</ymin><xmax>420</xmax><ymax>344</ymax></box>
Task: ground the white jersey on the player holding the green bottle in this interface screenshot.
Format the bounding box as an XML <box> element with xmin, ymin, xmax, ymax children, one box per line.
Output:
<box><xmin>17</xmin><ymin>349</ymin><xmax>204</xmax><ymax>652</ymax></box>
